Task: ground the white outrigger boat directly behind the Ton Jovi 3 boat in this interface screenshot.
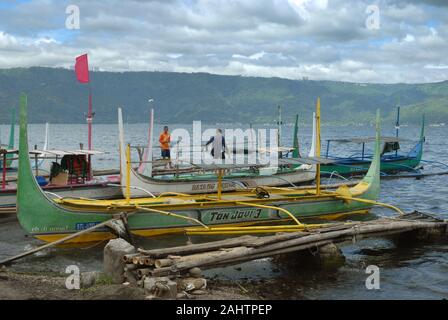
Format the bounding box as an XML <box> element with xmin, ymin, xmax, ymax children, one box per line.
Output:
<box><xmin>118</xmin><ymin>108</ymin><xmax>317</xmax><ymax>198</ymax></box>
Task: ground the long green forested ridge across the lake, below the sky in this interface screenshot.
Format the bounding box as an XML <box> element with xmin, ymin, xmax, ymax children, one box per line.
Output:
<box><xmin>0</xmin><ymin>67</ymin><xmax>448</xmax><ymax>126</ymax></box>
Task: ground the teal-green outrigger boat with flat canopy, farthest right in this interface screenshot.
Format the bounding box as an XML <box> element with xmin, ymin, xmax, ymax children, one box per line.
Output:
<box><xmin>321</xmin><ymin>108</ymin><xmax>425</xmax><ymax>176</ymax></box>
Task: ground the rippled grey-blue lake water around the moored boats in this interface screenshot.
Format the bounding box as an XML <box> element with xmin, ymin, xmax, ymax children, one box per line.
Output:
<box><xmin>0</xmin><ymin>120</ymin><xmax>448</xmax><ymax>299</ymax></box>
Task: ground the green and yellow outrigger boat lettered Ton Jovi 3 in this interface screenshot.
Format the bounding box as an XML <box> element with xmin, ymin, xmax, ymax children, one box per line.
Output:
<box><xmin>17</xmin><ymin>94</ymin><xmax>380</xmax><ymax>243</ymax></box>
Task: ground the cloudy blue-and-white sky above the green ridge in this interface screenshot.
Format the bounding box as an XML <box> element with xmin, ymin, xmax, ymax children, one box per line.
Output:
<box><xmin>0</xmin><ymin>0</ymin><xmax>448</xmax><ymax>83</ymax></box>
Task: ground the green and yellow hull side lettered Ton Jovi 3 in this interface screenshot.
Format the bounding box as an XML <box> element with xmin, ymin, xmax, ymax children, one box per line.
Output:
<box><xmin>29</xmin><ymin>199</ymin><xmax>371</xmax><ymax>243</ymax></box>
